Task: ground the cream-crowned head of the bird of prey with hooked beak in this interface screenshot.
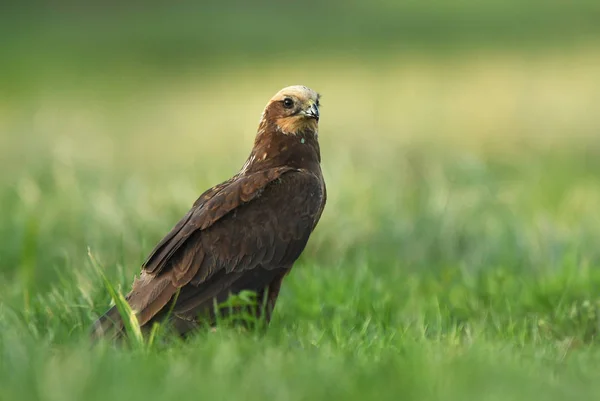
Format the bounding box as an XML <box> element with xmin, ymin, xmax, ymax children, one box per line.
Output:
<box><xmin>262</xmin><ymin>85</ymin><xmax>320</xmax><ymax>135</ymax></box>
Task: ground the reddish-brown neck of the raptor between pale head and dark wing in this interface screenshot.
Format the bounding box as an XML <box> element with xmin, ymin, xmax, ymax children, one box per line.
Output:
<box><xmin>244</xmin><ymin>124</ymin><xmax>321</xmax><ymax>172</ymax></box>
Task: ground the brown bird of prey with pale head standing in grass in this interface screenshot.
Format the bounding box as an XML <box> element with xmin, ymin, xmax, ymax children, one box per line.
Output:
<box><xmin>92</xmin><ymin>86</ymin><xmax>327</xmax><ymax>338</ymax></box>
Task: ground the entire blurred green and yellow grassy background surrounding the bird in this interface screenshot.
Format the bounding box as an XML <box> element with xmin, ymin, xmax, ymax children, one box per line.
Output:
<box><xmin>0</xmin><ymin>0</ymin><xmax>600</xmax><ymax>401</ymax></box>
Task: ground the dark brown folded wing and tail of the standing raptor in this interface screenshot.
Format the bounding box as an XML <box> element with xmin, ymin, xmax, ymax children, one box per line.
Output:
<box><xmin>94</xmin><ymin>167</ymin><xmax>324</xmax><ymax>334</ymax></box>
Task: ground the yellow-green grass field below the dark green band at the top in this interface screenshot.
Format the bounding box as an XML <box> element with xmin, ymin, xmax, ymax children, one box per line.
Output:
<box><xmin>0</xmin><ymin>49</ymin><xmax>600</xmax><ymax>401</ymax></box>
